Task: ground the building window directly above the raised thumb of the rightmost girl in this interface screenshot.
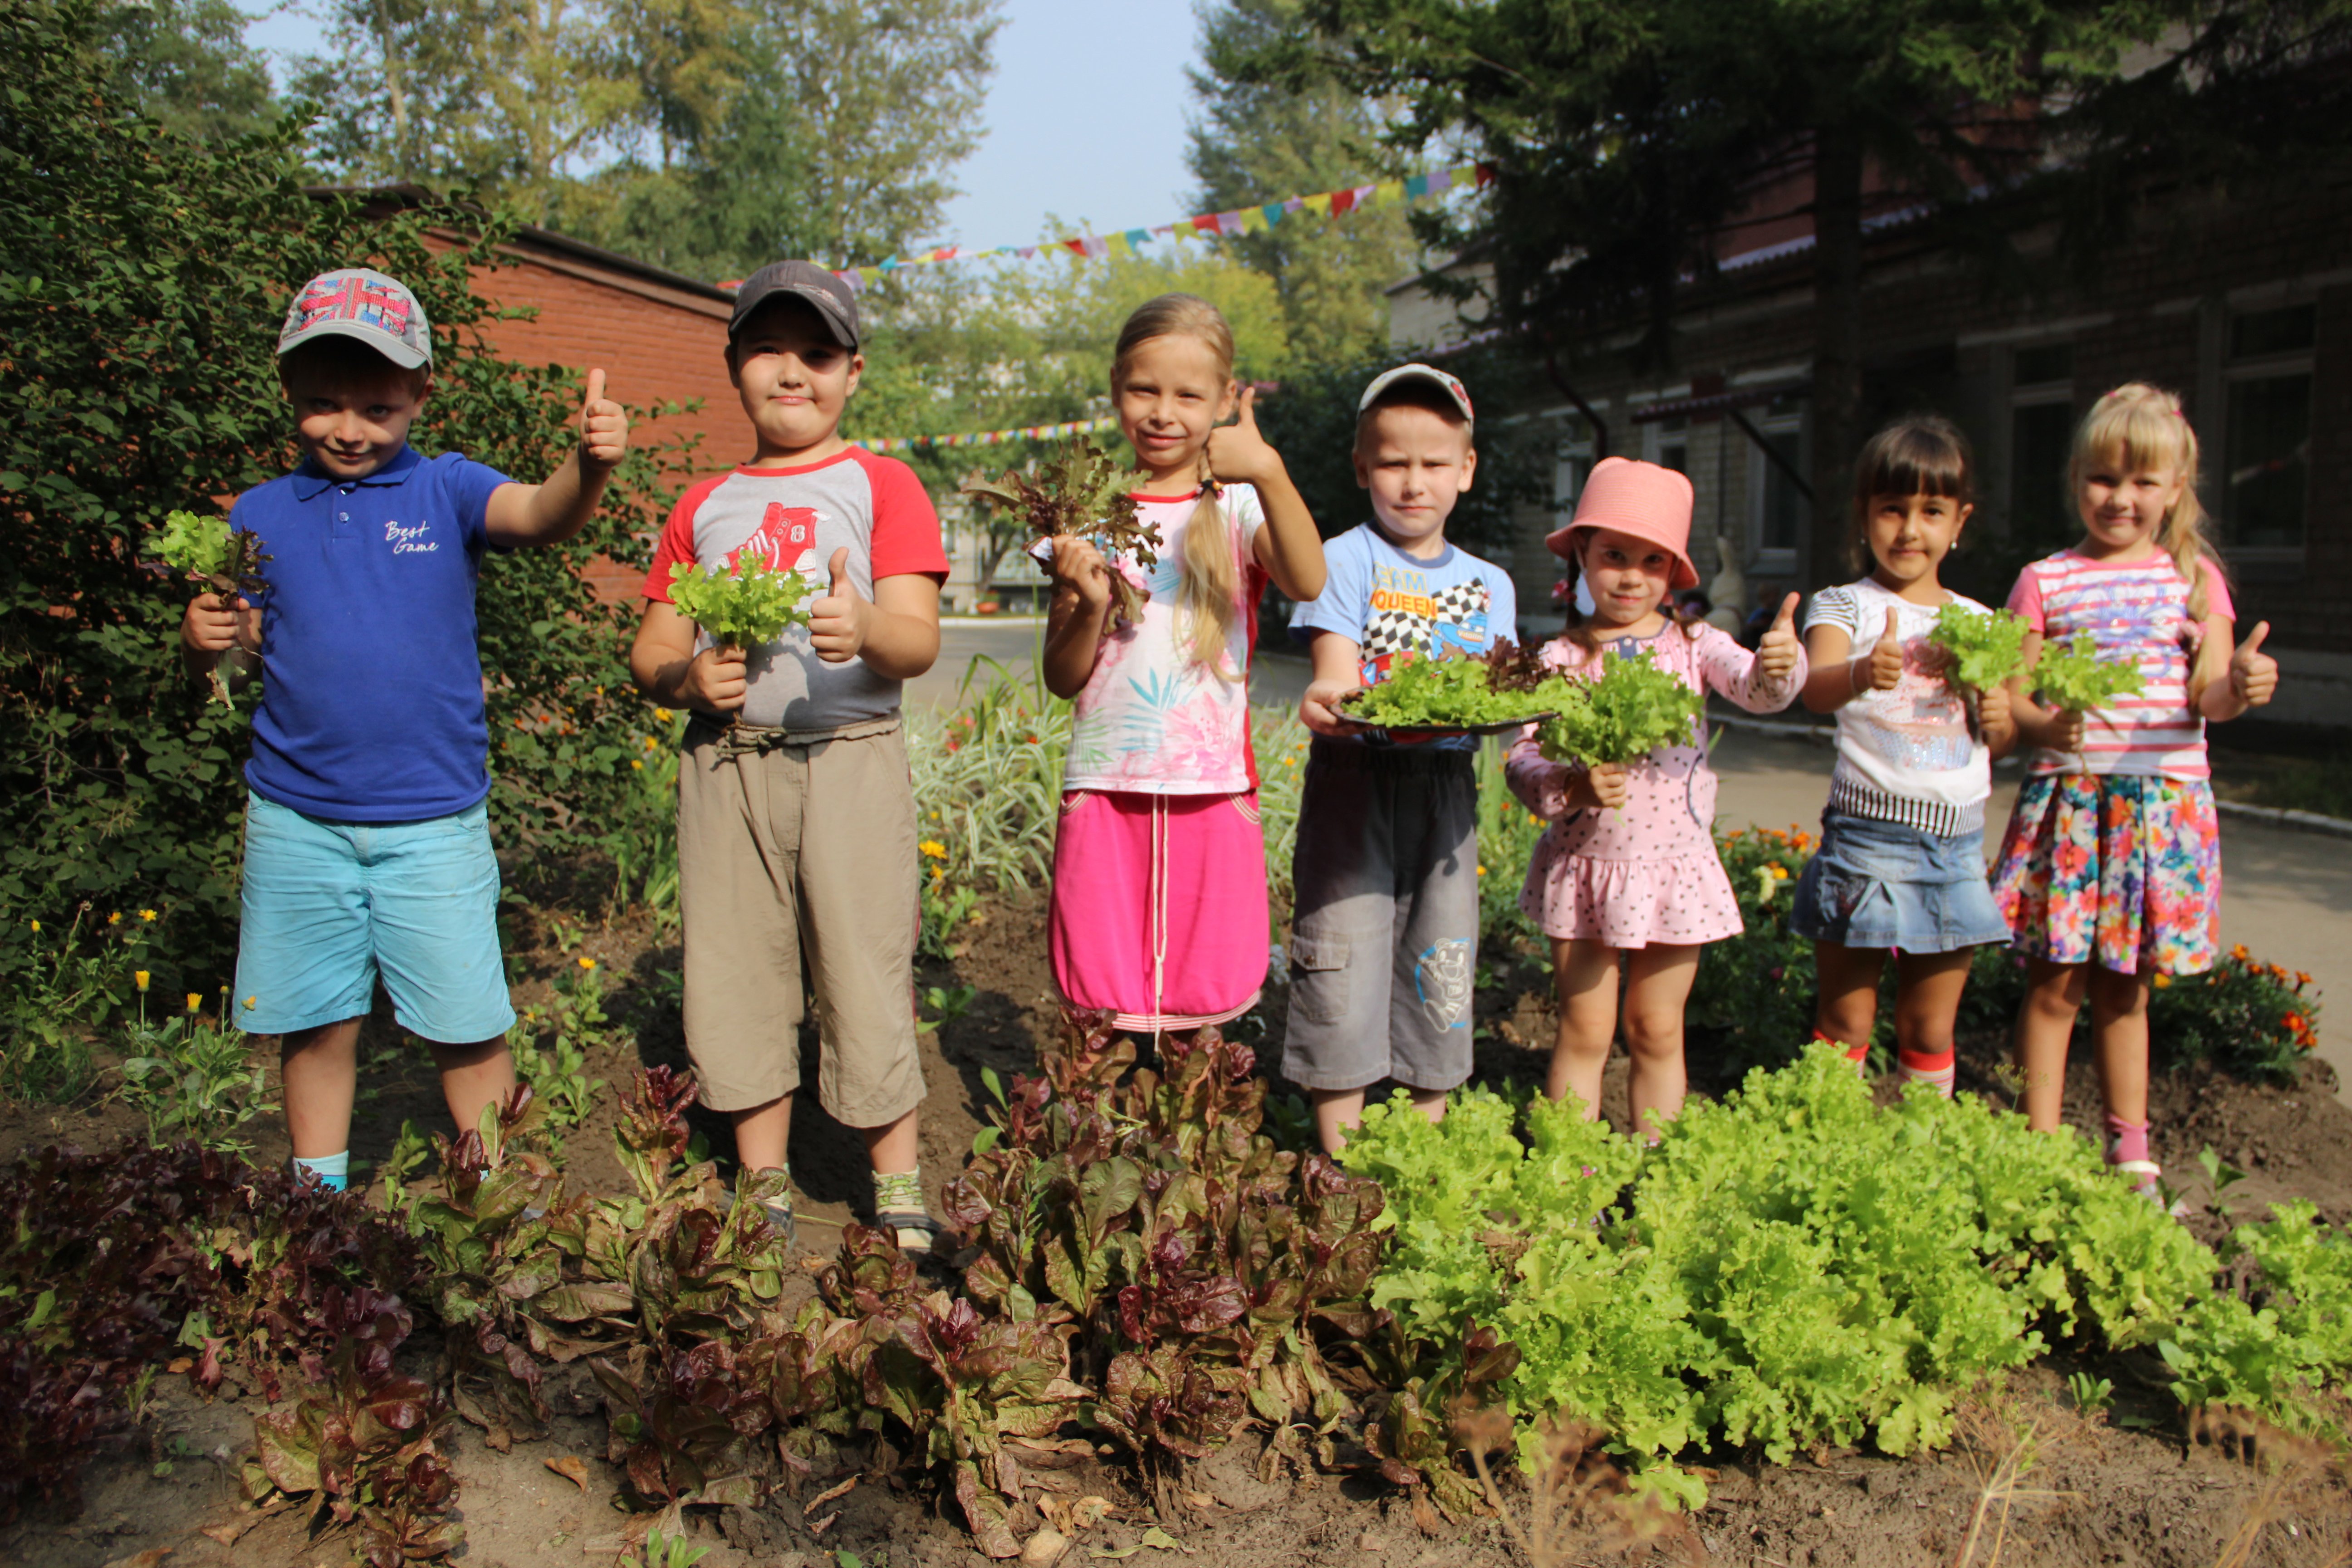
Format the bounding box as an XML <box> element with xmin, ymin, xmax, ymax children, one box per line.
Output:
<box><xmin>2209</xmin><ymin>306</ymin><xmax>2319</xmax><ymax>555</ymax></box>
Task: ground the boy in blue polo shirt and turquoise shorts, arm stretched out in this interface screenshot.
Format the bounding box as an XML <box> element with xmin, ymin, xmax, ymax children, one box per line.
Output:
<box><xmin>179</xmin><ymin>268</ymin><xmax>628</xmax><ymax>1187</ymax></box>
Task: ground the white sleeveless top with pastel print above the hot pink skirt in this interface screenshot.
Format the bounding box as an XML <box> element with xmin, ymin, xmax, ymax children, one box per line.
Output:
<box><xmin>1063</xmin><ymin>484</ymin><xmax>1265</xmax><ymax>794</ymax></box>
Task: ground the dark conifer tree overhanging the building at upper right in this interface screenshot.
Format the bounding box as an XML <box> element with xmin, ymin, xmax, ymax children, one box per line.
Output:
<box><xmin>1232</xmin><ymin>0</ymin><xmax>2345</xmax><ymax>583</ymax></box>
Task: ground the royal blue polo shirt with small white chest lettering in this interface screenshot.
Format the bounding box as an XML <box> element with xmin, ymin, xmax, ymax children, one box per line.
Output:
<box><xmin>228</xmin><ymin>446</ymin><xmax>508</xmax><ymax>823</ymax></box>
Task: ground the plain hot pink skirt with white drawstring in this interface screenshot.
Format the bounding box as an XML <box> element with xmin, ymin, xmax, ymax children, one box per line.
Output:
<box><xmin>1049</xmin><ymin>790</ymin><xmax>1270</xmax><ymax>1034</ymax></box>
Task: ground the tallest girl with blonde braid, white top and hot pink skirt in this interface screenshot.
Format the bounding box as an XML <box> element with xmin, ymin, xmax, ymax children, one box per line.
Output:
<box><xmin>1044</xmin><ymin>294</ymin><xmax>1324</xmax><ymax>1034</ymax></box>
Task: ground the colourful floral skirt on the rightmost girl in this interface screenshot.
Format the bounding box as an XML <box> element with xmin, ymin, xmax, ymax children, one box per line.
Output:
<box><xmin>1992</xmin><ymin>774</ymin><xmax>2220</xmax><ymax>975</ymax></box>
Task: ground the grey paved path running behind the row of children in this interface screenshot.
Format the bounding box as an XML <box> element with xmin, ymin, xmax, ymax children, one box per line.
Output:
<box><xmin>908</xmin><ymin>621</ymin><xmax>2352</xmax><ymax>1100</ymax></box>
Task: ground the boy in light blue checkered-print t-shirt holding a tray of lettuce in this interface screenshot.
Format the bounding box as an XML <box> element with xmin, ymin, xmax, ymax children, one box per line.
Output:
<box><xmin>1282</xmin><ymin>364</ymin><xmax>1519</xmax><ymax>1152</ymax></box>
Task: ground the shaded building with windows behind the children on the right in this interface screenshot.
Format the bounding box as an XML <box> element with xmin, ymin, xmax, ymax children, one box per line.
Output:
<box><xmin>1390</xmin><ymin>169</ymin><xmax>2352</xmax><ymax>726</ymax></box>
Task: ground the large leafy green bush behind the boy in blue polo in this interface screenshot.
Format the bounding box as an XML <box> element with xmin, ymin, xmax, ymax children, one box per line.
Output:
<box><xmin>0</xmin><ymin>0</ymin><xmax>686</xmax><ymax>1023</ymax></box>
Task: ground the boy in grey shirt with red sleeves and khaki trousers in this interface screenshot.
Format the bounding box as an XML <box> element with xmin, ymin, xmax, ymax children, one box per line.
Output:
<box><xmin>630</xmin><ymin>261</ymin><xmax>948</xmax><ymax>1251</ymax></box>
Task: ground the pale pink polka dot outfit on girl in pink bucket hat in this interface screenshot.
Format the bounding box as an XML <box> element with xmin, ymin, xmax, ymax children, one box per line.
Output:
<box><xmin>1505</xmin><ymin>625</ymin><xmax>1804</xmax><ymax>947</ymax></box>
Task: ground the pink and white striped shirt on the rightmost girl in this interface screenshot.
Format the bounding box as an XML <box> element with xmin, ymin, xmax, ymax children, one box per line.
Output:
<box><xmin>2009</xmin><ymin>550</ymin><xmax>2237</xmax><ymax>778</ymax></box>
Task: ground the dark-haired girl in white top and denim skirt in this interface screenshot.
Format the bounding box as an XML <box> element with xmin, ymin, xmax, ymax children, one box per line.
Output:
<box><xmin>1790</xmin><ymin>416</ymin><xmax>2016</xmax><ymax>1096</ymax></box>
